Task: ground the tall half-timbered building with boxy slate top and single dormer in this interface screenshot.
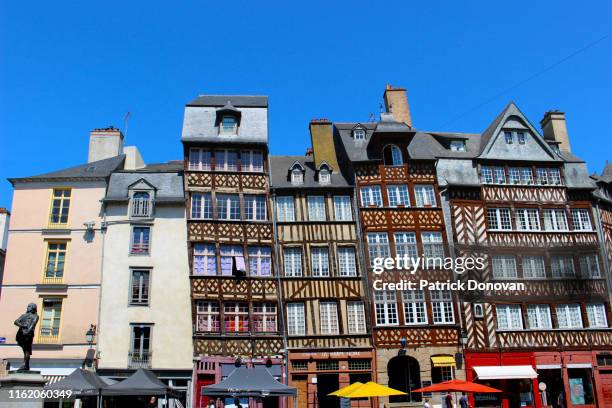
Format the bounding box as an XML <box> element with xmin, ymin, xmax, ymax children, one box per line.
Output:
<box><xmin>182</xmin><ymin>96</ymin><xmax>285</xmax><ymax>407</ymax></box>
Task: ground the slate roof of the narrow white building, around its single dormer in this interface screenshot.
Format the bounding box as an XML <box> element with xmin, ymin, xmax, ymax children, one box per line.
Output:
<box><xmin>104</xmin><ymin>162</ymin><xmax>185</xmax><ymax>203</ymax></box>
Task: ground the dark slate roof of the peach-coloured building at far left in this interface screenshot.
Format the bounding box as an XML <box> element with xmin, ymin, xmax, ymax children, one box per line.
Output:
<box><xmin>8</xmin><ymin>154</ymin><xmax>125</xmax><ymax>184</ymax></box>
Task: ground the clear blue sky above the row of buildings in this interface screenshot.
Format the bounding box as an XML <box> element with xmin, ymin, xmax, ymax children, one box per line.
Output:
<box><xmin>0</xmin><ymin>0</ymin><xmax>612</xmax><ymax>207</ymax></box>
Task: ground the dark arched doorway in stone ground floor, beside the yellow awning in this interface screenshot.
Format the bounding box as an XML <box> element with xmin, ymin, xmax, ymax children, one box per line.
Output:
<box><xmin>387</xmin><ymin>356</ymin><xmax>421</xmax><ymax>402</ymax></box>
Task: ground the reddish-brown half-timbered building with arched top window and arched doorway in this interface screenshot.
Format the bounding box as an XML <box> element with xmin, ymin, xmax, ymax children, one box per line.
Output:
<box><xmin>335</xmin><ymin>87</ymin><xmax>463</xmax><ymax>406</ymax></box>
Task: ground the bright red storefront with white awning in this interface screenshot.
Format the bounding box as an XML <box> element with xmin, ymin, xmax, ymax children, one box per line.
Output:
<box><xmin>465</xmin><ymin>352</ymin><xmax>542</xmax><ymax>408</ymax></box>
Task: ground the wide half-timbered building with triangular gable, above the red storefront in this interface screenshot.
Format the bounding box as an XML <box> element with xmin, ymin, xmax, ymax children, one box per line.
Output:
<box><xmin>440</xmin><ymin>103</ymin><xmax>612</xmax><ymax>407</ymax></box>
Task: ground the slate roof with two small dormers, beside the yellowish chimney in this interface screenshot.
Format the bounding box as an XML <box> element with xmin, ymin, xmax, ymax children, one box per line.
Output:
<box><xmin>270</xmin><ymin>156</ymin><xmax>351</xmax><ymax>189</ymax></box>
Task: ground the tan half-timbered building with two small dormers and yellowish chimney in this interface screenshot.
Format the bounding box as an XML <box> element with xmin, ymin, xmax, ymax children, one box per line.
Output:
<box><xmin>271</xmin><ymin>120</ymin><xmax>374</xmax><ymax>408</ymax></box>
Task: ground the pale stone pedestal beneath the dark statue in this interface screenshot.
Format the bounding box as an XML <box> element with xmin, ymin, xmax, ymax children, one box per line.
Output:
<box><xmin>0</xmin><ymin>370</ymin><xmax>46</xmax><ymax>408</ymax></box>
